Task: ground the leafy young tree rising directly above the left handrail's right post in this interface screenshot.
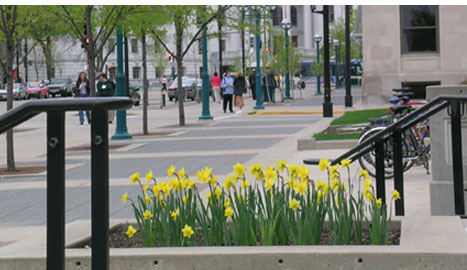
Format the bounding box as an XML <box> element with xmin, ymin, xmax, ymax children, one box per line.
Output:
<box><xmin>54</xmin><ymin>5</ymin><xmax>135</xmax><ymax>96</ymax></box>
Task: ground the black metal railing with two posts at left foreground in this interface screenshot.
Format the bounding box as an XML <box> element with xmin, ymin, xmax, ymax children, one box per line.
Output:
<box><xmin>0</xmin><ymin>97</ymin><xmax>133</xmax><ymax>270</ymax></box>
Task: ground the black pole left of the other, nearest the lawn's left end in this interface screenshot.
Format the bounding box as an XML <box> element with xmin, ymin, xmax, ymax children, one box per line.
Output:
<box><xmin>323</xmin><ymin>5</ymin><xmax>332</xmax><ymax>117</ymax></box>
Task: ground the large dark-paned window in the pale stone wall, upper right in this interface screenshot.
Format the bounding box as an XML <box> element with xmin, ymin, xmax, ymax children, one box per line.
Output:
<box><xmin>400</xmin><ymin>6</ymin><xmax>438</xmax><ymax>53</ymax></box>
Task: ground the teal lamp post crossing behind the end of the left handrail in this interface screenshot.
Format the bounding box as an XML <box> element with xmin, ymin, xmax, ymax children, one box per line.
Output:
<box><xmin>112</xmin><ymin>28</ymin><xmax>131</xmax><ymax>140</ymax></box>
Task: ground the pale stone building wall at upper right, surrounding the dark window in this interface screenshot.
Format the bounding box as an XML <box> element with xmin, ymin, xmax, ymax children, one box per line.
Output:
<box><xmin>362</xmin><ymin>5</ymin><xmax>467</xmax><ymax>104</ymax></box>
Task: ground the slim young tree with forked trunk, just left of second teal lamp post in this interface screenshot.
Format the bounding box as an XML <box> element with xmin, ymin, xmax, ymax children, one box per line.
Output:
<box><xmin>154</xmin><ymin>6</ymin><xmax>230</xmax><ymax>126</ymax></box>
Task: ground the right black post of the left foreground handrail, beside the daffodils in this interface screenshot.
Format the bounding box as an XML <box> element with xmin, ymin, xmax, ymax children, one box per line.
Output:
<box><xmin>91</xmin><ymin>110</ymin><xmax>109</xmax><ymax>270</ymax></box>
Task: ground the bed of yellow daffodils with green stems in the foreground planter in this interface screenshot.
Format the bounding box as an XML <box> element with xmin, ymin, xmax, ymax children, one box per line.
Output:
<box><xmin>115</xmin><ymin>159</ymin><xmax>399</xmax><ymax>247</ymax></box>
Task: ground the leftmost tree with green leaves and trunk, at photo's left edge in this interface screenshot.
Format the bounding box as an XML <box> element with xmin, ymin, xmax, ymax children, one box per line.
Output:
<box><xmin>0</xmin><ymin>5</ymin><xmax>34</xmax><ymax>172</ymax></box>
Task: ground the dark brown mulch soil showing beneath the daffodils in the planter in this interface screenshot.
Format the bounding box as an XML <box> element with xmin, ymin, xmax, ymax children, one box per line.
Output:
<box><xmin>72</xmin><ymin>223</ymin><xmax>401</xmax><ymax>248</ymax></box>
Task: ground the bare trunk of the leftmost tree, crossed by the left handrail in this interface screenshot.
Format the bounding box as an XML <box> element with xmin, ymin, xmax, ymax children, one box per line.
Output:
<box><xmin>5</xmin><ymin>37</ymin><xmax>16</xmax><ymax>172</ymax></box>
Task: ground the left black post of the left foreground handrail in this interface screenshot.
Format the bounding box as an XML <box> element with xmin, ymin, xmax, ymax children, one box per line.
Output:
<box><xmin>47</xmin><ymin>111</ymin><xmax>65</xmax><ymax>270</ymax></box>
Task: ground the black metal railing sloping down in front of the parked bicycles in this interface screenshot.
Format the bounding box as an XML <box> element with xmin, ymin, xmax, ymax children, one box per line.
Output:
<box><xmin>303</xmin><ymin>95</ymin><xmax>467</xmax><ymax>216</ymax></box>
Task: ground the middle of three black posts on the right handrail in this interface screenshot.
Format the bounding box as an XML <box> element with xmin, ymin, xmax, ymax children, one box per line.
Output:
<box><xmin>392</xmin><ymin>129</ymin><xmax>404</xmax><ymax>216</ymax></box>
